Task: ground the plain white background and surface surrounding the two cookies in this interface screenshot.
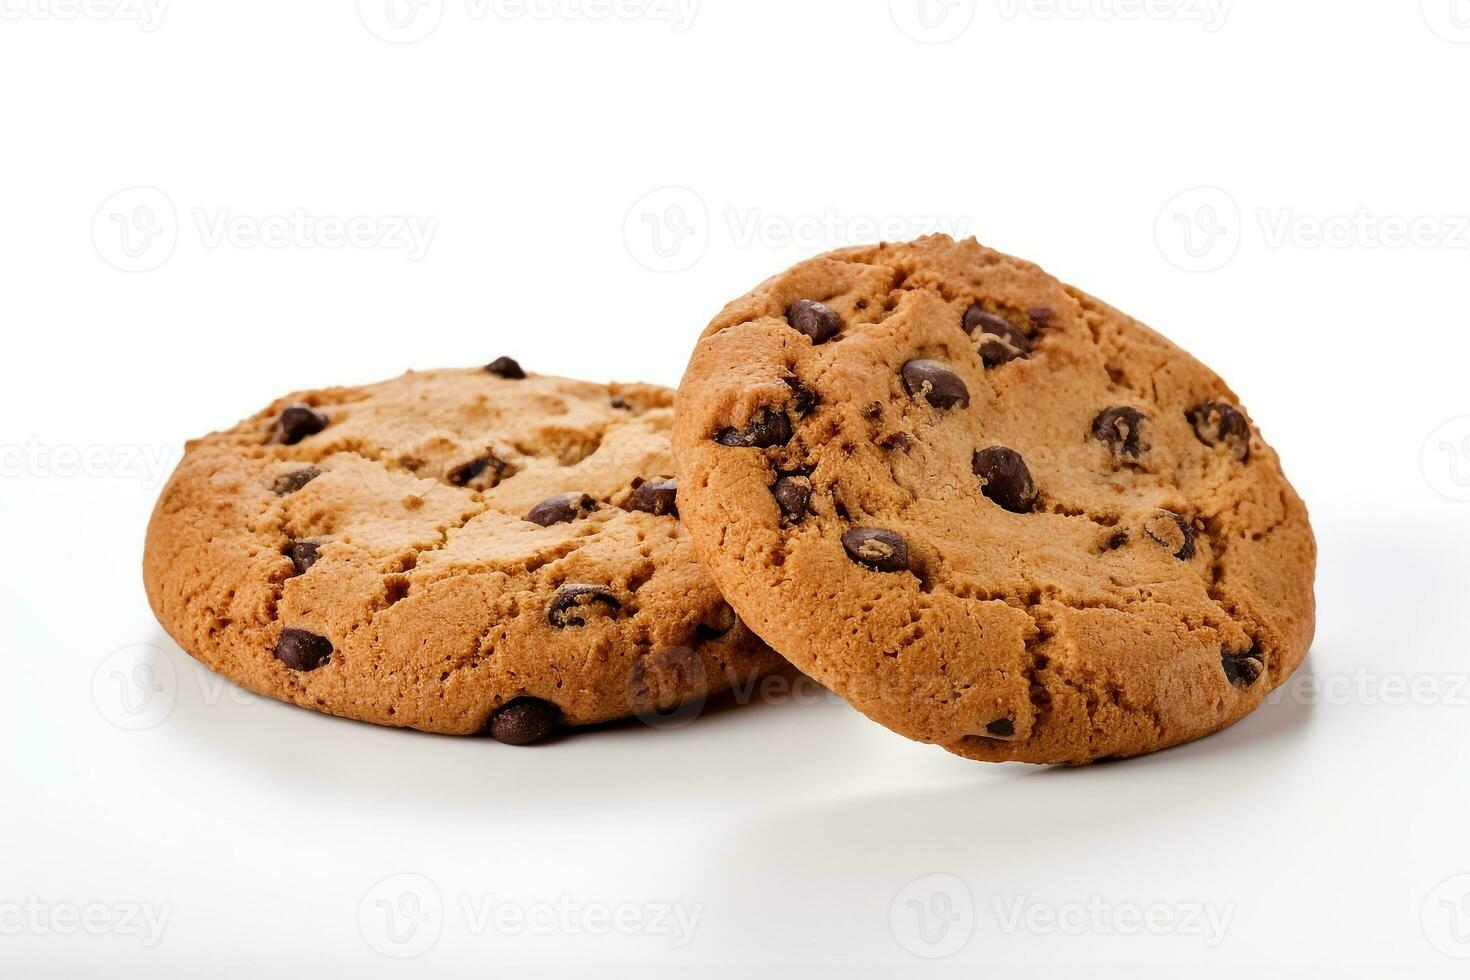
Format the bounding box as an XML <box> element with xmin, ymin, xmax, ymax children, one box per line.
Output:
<box><xmin>0</xmin><ymin>0</ymin><xmax>1470</xmax><ymax>977</ymax></box>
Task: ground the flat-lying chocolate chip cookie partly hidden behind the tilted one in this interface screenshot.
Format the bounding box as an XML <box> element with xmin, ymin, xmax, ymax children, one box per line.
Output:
<box><xmin>144</xmin><ymin>367</ymin><xmax>782</xmax><ymax>745</ymax></box>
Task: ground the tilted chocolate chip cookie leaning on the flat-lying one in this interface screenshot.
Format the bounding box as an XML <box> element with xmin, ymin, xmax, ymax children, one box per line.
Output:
<box><xmin>675</xmin><ymin>237</ymin><xmax>1316</xmax><ymax>763</ymax></box>
